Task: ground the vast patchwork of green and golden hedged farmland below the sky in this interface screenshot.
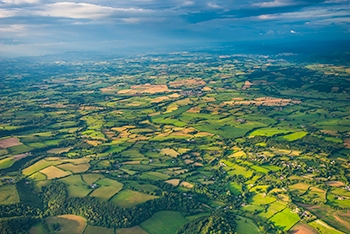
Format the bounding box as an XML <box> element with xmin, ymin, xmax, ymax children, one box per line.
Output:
<box><xmin>0</xmin><ymin>53</ymin><xmax>350</xmax><ymax>234</ymax></box>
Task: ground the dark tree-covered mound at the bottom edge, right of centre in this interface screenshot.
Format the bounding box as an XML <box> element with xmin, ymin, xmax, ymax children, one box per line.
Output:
<box><xmin>176</xmin><ymin>211</ymin><xmax>237</xmax><ymax>234</ymax></box>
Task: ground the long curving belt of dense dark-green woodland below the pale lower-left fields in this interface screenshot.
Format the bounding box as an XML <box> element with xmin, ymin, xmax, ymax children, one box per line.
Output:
<box><xmin>42</xmin><ymin>181</ymin><xmax>201</xmax><ymax>228</ymax></box>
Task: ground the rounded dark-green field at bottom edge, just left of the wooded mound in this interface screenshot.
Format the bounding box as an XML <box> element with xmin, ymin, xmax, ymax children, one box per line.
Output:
<box><xmin>140</xmin><ymin>211</ymin><xmax>188</xmax><ymax>234</ymax></box>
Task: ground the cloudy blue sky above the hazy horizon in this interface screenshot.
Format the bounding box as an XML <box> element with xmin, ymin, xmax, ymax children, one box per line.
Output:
<box><xmin>0</xmin><ymin>0</ymin><xmax>350</xmax><ymax>57</ymax></box>
